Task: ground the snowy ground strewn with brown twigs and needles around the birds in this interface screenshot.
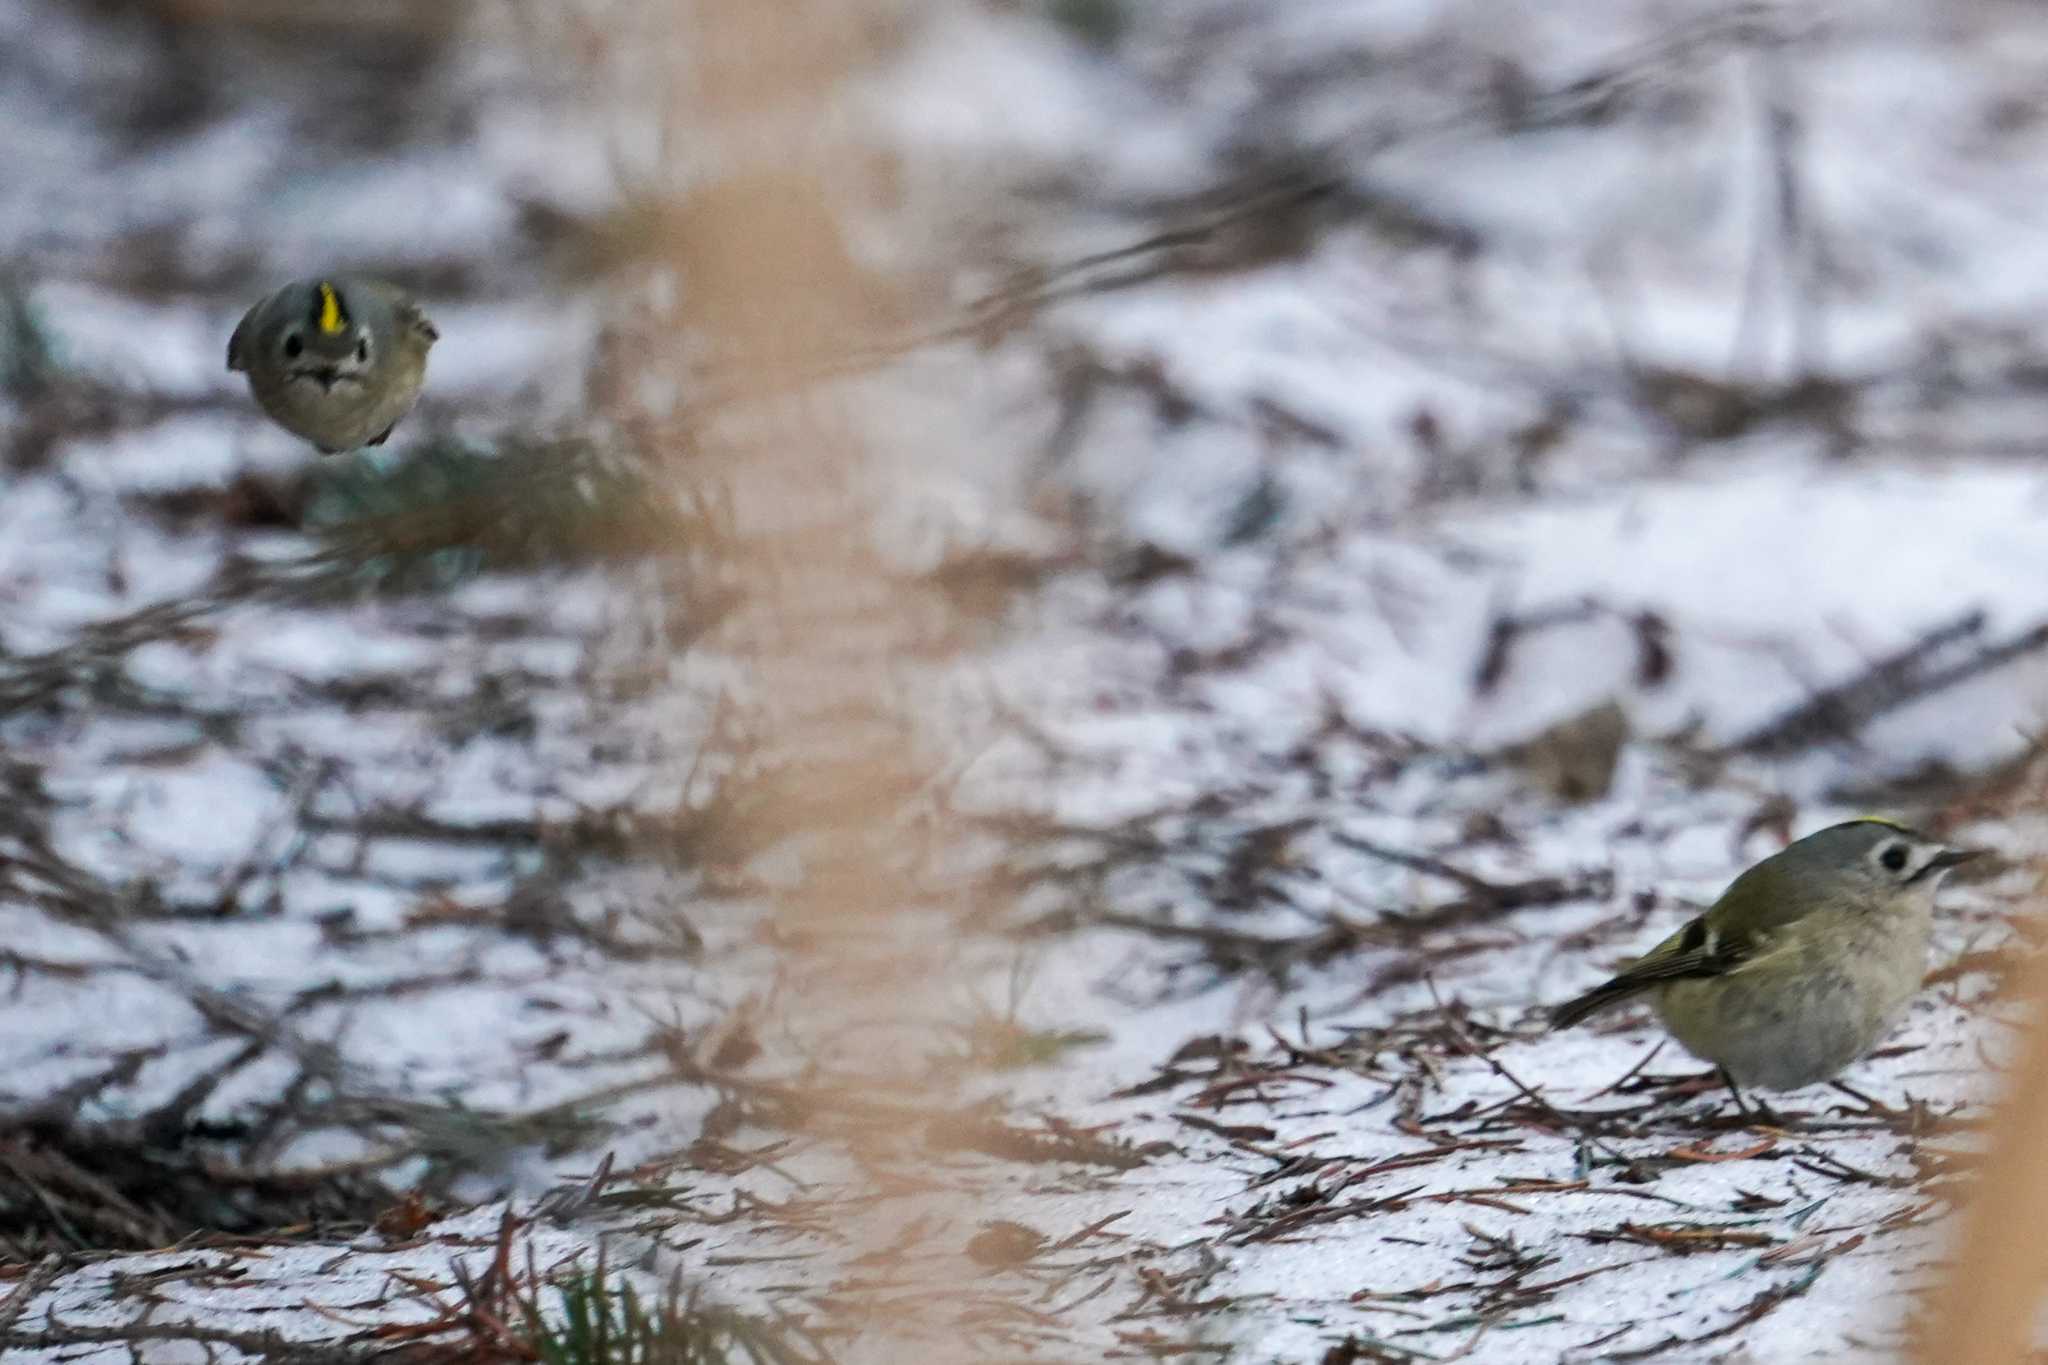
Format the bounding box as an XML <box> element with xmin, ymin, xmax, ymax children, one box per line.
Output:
<box><xmin>0</xmin><ymin>0</ymin><xmax>2048</xmax><ymax>1361</ymax></box>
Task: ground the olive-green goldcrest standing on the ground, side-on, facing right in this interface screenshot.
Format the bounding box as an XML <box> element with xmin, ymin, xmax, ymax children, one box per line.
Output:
<box><xmin>1550</xmin><ymin>821</ymin><xmax>1978</xmax><ymax>1091</ymax></box>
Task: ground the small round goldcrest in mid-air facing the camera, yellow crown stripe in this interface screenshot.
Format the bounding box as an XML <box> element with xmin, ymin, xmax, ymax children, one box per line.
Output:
<box><xmin>227</xmin><ymin>276</ymin><xmax>440</xmax><ymax>454</ymax></box>
